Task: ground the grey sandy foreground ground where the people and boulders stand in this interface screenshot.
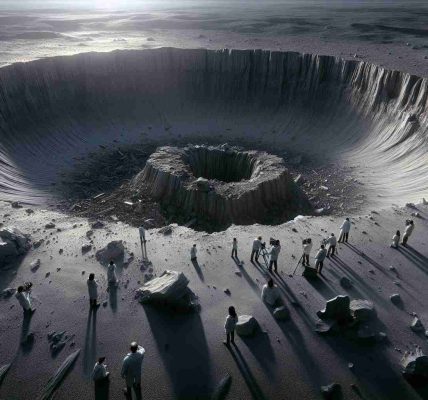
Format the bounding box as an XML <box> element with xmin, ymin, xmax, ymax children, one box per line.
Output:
<box><xmin>0</xmin><ymin>203</ymin><xmax>428</xmax><ymax>400</ymax></box>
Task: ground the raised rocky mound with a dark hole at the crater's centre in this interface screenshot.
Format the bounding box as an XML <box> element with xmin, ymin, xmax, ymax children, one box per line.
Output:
<box><xmin>132</xmin><ymin>145</ymin><xmax>311</xmax><ymax>225</ymax></box>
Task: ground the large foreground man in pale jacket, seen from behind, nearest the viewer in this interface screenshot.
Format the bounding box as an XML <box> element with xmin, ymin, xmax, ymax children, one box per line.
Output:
<box><xmin>121</xmin><ymin>342</ymin><xmax>146</xmax><ymax>400</ymax></box>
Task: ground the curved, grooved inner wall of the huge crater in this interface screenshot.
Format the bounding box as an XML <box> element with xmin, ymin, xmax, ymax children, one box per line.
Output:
<box><xmin>0</xmin><ymin>48</ymin><xmax>428</xmax><ymax>205</ymax></box>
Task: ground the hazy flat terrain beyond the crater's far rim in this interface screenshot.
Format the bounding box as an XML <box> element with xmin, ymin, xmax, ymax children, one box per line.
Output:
<box><xmin>0</xmin><ymin>0</ymin><xmax>428</xmax><ymax>70</ymax></box>
